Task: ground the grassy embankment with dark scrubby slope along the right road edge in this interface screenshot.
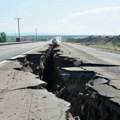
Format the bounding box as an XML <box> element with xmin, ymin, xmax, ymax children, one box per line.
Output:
<box><xmin>65</xmin><ymin>36</ymin><xmax>120</xmax><ymax>51</ymax></box>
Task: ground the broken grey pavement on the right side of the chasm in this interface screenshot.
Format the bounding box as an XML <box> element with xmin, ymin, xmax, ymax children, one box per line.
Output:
<box><xmin>62</xmin><ymin>43</ymin><xmax>120</xmax><ymax>104</ymax></box>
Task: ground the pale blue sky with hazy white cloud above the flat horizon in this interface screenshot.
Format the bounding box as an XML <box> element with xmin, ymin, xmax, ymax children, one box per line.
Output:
<box><xmin>0</xmin><ymin>0</ymin><xmax>120</xmax><ymax>35</ymax></box>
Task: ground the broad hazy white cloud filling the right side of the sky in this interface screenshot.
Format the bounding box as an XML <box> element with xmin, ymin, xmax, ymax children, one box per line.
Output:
<box><xmin>56</xmin><ymin>6</ymin><xmax>120</xmax><ymax>34</ymax></box>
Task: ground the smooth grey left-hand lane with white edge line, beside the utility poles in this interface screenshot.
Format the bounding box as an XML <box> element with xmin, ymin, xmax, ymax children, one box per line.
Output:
<box><xmin>0</xmin><ymin>42</ymin><xmax>47</xmax><ymax>62</ymax></box>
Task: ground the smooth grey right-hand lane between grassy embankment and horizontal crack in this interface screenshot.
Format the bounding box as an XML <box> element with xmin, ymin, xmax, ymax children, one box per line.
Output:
<box><xmin>67</xmin><ymin>43</ymin><xmax>120</xmax><ymax>65</ymax></box>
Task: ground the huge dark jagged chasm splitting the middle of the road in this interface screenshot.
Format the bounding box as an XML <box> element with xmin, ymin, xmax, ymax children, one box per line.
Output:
<box><xmin>18</xmin><ymin>44</ymin><xmax>120</xmax><ymax>120</ymax></box>
